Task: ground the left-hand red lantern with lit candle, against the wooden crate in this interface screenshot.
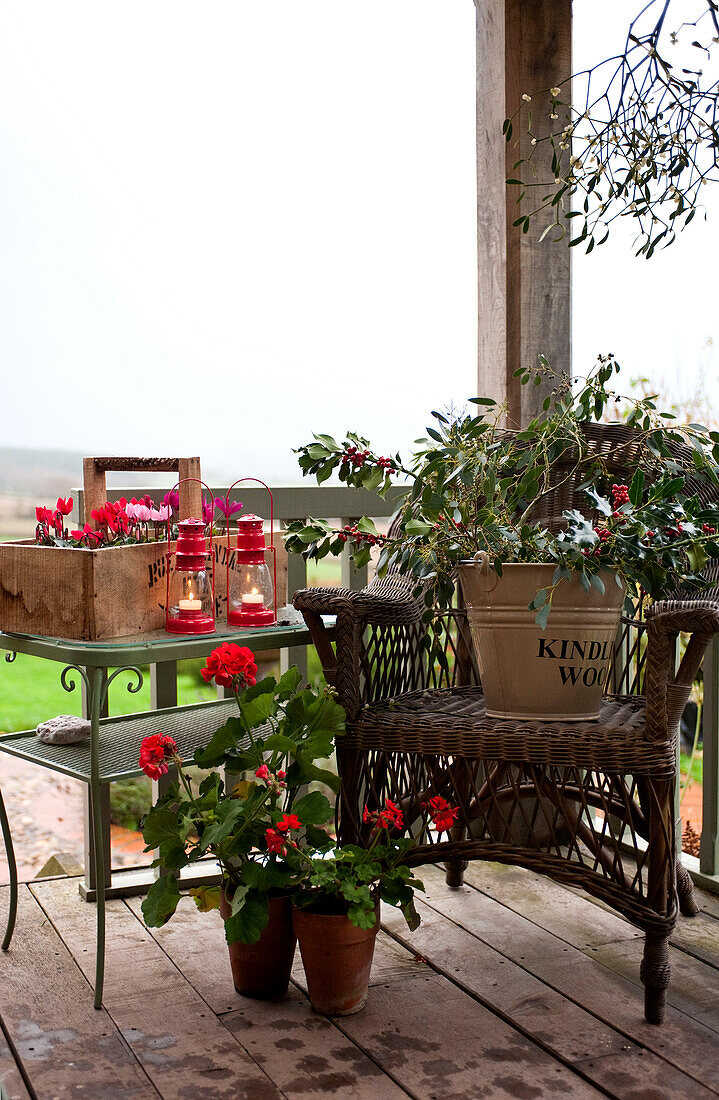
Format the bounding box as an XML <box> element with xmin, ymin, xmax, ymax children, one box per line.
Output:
<box><xmin>165</xmin><ymin>479</ymin><xmax>214</xmax><ymax>634</ymax></box>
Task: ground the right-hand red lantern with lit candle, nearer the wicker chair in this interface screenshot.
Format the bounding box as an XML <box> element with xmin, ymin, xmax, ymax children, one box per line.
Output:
<box><xmin>226</xmin><ymin>477</ymin><xmax>277</xmax><ymax>628</ymax></box>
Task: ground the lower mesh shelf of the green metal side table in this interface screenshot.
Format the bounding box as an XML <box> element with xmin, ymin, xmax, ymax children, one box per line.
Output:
<box><xmin>0</xmin><ymin>699</ymin><xmax>244</xmax><ymax>783</ymax></box>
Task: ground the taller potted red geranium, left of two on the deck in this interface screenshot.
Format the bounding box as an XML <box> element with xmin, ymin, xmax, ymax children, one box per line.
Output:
<box><xmin>140</xmin><ymin>642</ymin><xmax>344</xmax><ymax>998</ymax></box>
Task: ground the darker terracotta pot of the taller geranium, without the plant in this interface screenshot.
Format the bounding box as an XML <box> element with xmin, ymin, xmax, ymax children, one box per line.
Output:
<box><xmin>220</xmin><ymin>891</ymin><xmax>297</xmax><ymax>1001</ymax></box>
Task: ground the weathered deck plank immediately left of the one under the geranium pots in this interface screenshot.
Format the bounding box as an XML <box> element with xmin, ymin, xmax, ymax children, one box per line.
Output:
<box><xmin>32</xmin><ymin>879</ymin><xmax>281</xmax><ymax>1100</ymax></box>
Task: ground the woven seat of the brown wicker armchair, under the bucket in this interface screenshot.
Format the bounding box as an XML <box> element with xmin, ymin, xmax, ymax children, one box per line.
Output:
<box><xmin>343</xmin><ymin>685</ymin><xmax>676</xmax><ymax>779</ymax></box>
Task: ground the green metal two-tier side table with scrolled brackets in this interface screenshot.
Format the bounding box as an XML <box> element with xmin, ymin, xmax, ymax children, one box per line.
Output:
<box><xmin>0</xmin><ymin>625</ymin><xmax>323</xmax><ymax>1009</ymax></box>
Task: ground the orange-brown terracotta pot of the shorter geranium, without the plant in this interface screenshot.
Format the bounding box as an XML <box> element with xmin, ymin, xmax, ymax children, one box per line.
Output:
<box><xmin>294</xmin><ymin>901</ymin><xmax>379</xmax><ymax>1016</ymax></box>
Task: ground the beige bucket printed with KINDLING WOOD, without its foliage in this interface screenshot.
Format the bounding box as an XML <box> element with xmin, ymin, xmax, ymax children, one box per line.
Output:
<box><xmin>458</xmin><ymin>561</ymin><xmax>624</xmax><ymax>722</ymax></box>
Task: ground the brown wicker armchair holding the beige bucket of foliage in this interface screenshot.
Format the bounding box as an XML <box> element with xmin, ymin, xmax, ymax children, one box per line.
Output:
<box><xmin>295</xmin><ymin>426</ymin><xmax>719</xmax><ymax>1023</ymax></box>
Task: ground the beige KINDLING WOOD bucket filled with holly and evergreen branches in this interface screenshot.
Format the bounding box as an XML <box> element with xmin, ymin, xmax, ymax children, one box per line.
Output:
<box><xmin>287</xmin><ymin>355</ymin><xmax>719</xmax><ymax>718</ymax></box>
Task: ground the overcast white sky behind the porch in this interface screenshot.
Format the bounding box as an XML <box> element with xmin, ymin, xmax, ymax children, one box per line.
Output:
<box><xmin>0</xmin><ymin>0</ymin><xmax>719</xmax><ymax>481</ymax></box>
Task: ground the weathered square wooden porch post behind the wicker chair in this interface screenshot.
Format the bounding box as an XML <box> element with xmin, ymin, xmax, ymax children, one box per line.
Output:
<box><xmin>475</xmin><ymin>0</ymin><xmax>572</xmax><ymax>425</ymax></box>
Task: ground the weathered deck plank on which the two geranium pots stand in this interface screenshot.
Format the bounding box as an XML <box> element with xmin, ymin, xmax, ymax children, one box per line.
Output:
<box><xmin>128</xmin><ymin>898</ymin><xmax>413</xmax><ymax>1100</ymax></box>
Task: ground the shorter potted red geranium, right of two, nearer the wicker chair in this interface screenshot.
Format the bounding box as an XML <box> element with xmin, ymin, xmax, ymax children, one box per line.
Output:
<box><xmin>288</xmin><ymin>795</ymin><xmax>458</xmax><ymax>1016</ymax></box>
